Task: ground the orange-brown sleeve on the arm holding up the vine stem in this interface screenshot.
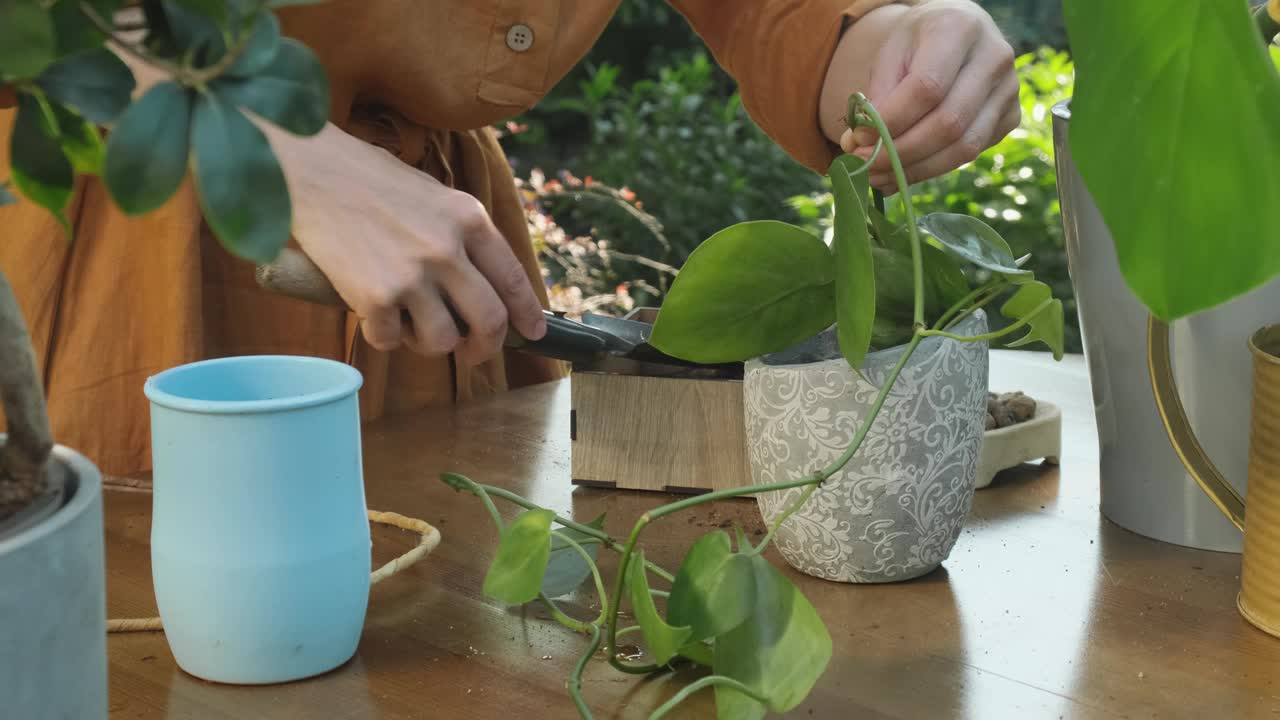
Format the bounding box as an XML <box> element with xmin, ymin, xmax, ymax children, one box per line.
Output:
<box><xmin>668</xmin><ymin>0</ymin><xmax>920</xmax><ymax>173</ymax></box>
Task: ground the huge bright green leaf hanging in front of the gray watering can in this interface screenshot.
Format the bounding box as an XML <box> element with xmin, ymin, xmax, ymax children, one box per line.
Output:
<box><xmin>1062</xmin><ymin>0</ymin><xmax>1280</xmax><ymax>322</ymax></box>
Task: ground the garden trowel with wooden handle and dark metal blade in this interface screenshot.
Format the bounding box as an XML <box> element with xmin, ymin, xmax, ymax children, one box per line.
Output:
<box><xmin>257</xmin><ymin>249</ymin><xmax>741</xmax><ymax>378</ymax></box>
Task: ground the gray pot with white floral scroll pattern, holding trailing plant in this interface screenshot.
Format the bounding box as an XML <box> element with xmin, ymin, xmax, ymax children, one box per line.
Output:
<box><xmin>744</xmin><ymin>310</ymin><xmax>988</xmax><ymax>583</ymax></box>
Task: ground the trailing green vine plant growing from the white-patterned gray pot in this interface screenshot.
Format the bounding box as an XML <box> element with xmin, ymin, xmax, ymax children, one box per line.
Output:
<box><xmin>443</xmin><ymin>95</ymin><xmax>1062</xmax><ymax>720</ymax></box>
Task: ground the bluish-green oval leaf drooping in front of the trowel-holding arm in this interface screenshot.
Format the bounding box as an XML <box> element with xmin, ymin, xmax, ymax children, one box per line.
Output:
<box><xmin>191</xmin><ymin>94</ymin><xmax>293</xmax><ymax>263</ymax></box>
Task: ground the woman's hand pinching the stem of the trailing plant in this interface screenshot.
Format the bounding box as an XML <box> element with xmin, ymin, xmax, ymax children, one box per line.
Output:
<box><xmin>823</xmin><ymin>0</ymin><xmax>1021</xmax><ymax>191</ymax></box>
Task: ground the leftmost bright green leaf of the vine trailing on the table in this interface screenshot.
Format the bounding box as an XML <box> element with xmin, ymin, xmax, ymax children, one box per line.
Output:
<box><xmin>484</xmin><ymin>509</ymin><xmax>556</xmax><ymax>605</ymax></box>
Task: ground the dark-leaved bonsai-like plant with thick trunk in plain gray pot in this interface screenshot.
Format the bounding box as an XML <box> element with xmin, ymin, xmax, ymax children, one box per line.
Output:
<box><xmin>0</xmin><ymin>0</ymin><xmax>329</xmax><ymax>519</ymax></box>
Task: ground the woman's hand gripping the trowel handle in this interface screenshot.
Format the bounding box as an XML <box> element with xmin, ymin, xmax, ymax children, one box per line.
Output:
<box><xmin>267</xmin><ymin>123</ymin><xmax>547</xmax><ymax>364</ymax></box>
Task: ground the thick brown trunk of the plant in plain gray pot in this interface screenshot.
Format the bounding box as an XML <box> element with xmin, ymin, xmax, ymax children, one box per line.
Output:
<box><xmin>0</xmin><ymin>273</ymin><xmax>54</xmax><ymax>520</ymax></box>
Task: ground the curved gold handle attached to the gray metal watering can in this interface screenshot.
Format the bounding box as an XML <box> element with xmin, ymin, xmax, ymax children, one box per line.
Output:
<box><xmin>1147</xmin><ymin>316</ymin><xmax>1244</xmax><ymax>530</ymax></box>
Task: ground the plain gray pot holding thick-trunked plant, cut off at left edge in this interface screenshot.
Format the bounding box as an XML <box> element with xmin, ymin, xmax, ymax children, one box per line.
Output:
<box><xmin>0</xmin><ymin>436</ymin><xmax>108</xmax><ymax>720</ymax></box>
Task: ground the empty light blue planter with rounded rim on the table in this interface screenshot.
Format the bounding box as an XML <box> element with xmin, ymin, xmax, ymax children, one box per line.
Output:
<box><xmin>146</xmin><ymin>356</ymin><xmax>371</xmax><ymax>684</ymax></box>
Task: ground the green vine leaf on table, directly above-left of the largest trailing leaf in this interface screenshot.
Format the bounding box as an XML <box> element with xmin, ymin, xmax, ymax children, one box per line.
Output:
<box><xmin>667</xmin><ymin>530</ymin><xmax>755</xmax><ymax>641</ymax></box>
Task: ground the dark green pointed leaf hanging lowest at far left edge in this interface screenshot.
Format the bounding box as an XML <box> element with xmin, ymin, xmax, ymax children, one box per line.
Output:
<box><xmin>9</xmin><ymin>94</ymin><xmax>76</xmax><ymax>218</ymax></box>
